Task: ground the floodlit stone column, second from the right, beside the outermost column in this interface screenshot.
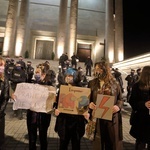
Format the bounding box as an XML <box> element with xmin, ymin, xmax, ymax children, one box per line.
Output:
<box><xmin>105</xmin><ymin>0</ymin><xmax>114</xmax><ymax>63</ymax></box>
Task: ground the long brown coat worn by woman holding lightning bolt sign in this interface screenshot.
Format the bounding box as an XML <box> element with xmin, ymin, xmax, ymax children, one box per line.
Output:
<box><xmin>88</xmin><ymin>78</ymin><xmax>123</xmax><ymax>150</ymax></box>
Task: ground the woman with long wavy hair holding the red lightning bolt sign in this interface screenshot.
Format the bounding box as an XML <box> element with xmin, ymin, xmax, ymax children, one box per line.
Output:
<box><xmin>88</xmin><ymin>61</ymin><xmax>123</xmax><ymax>150</ymax></box>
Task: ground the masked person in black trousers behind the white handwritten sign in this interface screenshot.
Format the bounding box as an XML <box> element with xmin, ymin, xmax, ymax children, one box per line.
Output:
<box><xmin>27</xmin><ymin>66</ymin><xmax>54</xmax><ymax>150</ymax></box>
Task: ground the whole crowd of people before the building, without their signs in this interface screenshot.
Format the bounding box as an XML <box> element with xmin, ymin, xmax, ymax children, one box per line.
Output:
<box><xmin>0</xmin><ymin>53</ymin><xmax>150</xmax><ymax>150</ymax></box>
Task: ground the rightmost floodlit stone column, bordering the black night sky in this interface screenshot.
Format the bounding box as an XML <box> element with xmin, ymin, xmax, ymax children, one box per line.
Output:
<box><xmin>115</xmin><ymin>0</ymin><xmax>124</xmax><ymax>62</ymax></box>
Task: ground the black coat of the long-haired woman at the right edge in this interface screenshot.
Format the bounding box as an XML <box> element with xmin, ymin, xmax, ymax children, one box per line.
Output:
<box><xmin>129</xmin><ymin>82</ymin><xmax>150</xmax><ymax>143</ymax></box>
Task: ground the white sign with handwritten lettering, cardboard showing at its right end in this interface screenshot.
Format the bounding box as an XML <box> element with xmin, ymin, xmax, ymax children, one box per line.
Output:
<box><xmin>13</xmin><ymin>83</ymin><xmax>56</xmax><ymax>113</ymax></box>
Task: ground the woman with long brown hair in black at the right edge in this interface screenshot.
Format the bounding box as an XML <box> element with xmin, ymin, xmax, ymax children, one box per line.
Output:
<box><xmin>129</xmin><ymin>66</ymin><xmax>150</xmax><ymax>150</ymax></box>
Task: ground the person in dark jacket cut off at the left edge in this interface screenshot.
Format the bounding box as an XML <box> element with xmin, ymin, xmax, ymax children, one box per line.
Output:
<box><xmin>0</xmin><ymin>57</ymin><xmax>9</xmax><ymax>150</ymax></box>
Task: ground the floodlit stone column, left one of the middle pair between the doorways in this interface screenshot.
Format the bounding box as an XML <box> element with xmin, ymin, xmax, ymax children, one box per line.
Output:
<box><xmin>56</xmin><ymin>0</ymin><xmax>68</xmax><ymax>58</ymax></box>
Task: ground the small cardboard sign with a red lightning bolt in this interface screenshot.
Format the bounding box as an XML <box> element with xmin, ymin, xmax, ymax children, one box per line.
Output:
<box><xmin>94</xmin><ymin>94</ymin><xmax>115</xmax><ymax>120</ymax></box>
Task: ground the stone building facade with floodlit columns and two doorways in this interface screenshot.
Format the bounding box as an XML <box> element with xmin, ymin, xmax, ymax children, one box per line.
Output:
<box><xmin>0</xmin><ymin>0</ymin><xmax>124</xmax><ymax>63</ymax></box>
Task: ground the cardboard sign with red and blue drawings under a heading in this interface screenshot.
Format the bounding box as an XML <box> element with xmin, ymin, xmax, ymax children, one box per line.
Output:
<box><xmin>58</xmin><ymin>85</ymin><xmax>91</xmax><ymax>115</ymax></box>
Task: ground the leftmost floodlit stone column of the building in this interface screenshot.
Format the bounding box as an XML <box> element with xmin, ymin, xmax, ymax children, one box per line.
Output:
<box><xmin>2</xmin><ymin>0</ymin><xmax>18</xmax><ymax>56</ymax></box>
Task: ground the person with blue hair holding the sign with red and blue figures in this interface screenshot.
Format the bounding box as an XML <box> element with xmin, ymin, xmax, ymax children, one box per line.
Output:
<box><xmin>55</xmin><ymin>68</ymin><xmax>89</xmax><ymax>150</ymax></box>
